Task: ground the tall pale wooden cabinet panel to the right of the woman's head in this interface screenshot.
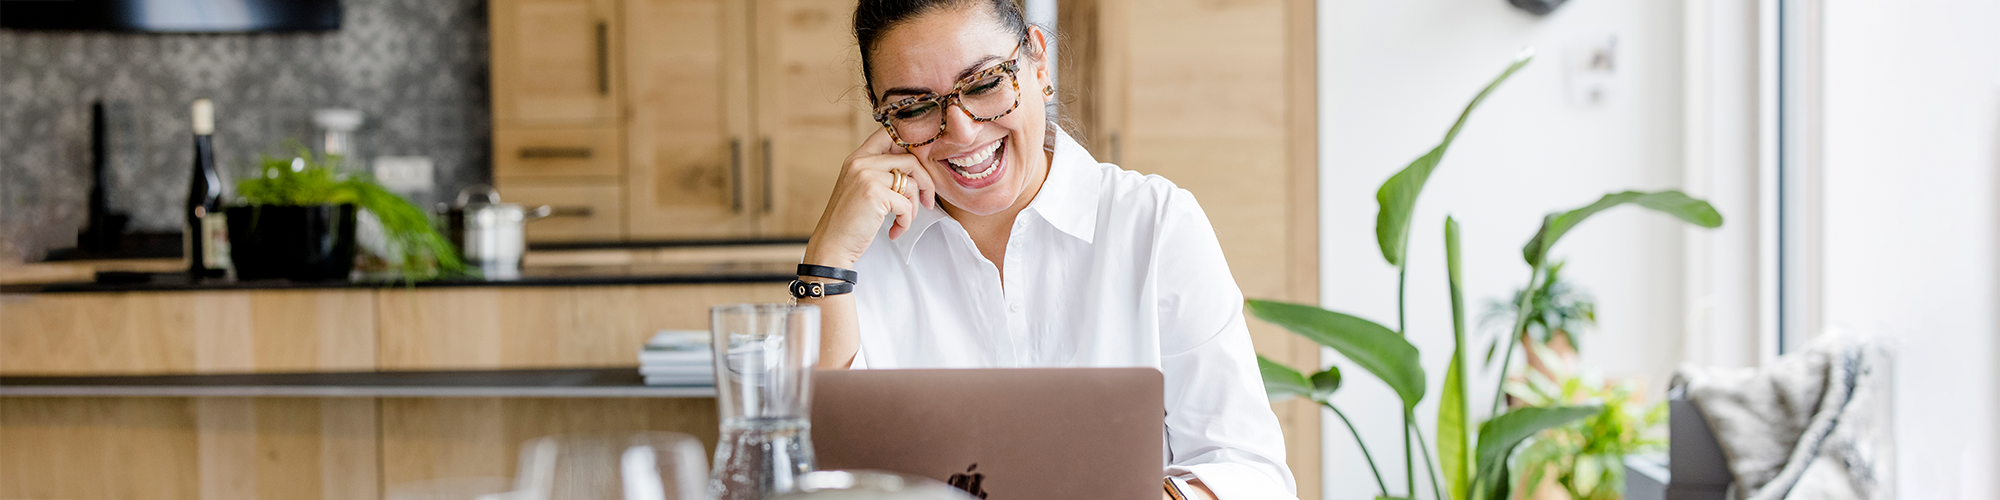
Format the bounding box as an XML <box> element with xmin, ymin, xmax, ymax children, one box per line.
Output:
<box><xmin>1058</xmin><ymin>0</ymin><xmax>1320</xmax><ymax>494</ymax></box>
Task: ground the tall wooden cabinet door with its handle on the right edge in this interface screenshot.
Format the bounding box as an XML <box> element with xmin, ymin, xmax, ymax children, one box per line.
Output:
<box><xmin>624</xmin><ymin>0</ymin><xmax>760</xmax><ymax>240</ymax></box>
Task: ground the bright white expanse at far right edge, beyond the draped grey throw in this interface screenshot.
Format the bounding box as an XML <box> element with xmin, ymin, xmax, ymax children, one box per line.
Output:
<box><xmin>1824</xmin><ymin>0</ymin><xmax>2000</xmax><ymax>498</ymax></box>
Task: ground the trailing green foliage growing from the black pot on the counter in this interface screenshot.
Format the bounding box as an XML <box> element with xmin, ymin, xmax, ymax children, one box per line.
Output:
<box><xmin>236</xmin><ymin>146</ymin><xmax>466</xmax><ymax>280</ymax></box>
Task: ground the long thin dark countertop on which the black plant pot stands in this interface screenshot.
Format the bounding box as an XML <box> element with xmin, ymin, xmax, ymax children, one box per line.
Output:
<box><xmin>0</xmin><ymin>262</ymin><xmax>796</xmax><ymax>294</ymax></box>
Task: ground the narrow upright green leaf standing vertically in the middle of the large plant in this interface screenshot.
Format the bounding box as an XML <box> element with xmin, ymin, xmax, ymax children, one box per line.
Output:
<box><xmin>1438</xmin><ymin>216</ymin><xmax>1472</xmax><ymax>500</ymax></box>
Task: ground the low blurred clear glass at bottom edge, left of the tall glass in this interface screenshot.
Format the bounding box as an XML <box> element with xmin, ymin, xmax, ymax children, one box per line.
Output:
<box><xmin>510</xmin><ymin>432</ymin><xmax>710</xmax><ymax>500</ymax></box>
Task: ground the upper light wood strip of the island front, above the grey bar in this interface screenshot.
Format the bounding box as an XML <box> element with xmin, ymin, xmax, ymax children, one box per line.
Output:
<box><xmin>0</xmin><ymin>284</ymin><xmax>786</xmax><ymax>376</ymax></box>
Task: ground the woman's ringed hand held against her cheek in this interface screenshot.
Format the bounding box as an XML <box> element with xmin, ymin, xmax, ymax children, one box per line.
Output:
<box><xmin>806</xmin><ymin>130</ymin><xmax>938</xmax><ymax>268</ymax></box>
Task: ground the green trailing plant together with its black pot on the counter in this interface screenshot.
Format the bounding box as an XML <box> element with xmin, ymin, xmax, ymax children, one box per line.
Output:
<box><xmin>228</xmin><ymin>148</ymin><xmax>464</xmax><ymax>282</ymax></box>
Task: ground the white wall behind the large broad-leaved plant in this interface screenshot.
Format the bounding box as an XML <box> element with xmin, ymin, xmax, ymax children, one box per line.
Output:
<box><xmin>1318</xmin><ymin>0</ymin><xmax>1696</xmax><ymax>498</ymax></box>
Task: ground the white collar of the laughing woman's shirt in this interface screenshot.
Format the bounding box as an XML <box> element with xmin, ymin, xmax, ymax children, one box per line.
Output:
<box><xmin>884</xmin><ymin>124</ymin><xmax>1102</xmax><ymax>262</ymax></box>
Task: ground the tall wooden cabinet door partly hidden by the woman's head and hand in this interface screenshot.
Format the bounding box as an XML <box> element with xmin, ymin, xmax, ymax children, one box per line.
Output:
<box><xmin>754</xmin><ymin>0</ymin><xmax>874</xmax><ymax>238</ymax></box>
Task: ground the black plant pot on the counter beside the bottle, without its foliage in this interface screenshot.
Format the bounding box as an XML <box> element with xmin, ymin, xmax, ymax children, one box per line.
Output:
<box><xmin>228</xmin><ymin>204</ymin><xmax>354</xmax><ymax>282</ymax></box>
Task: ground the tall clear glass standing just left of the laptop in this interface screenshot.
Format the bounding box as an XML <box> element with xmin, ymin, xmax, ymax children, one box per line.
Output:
<box><xmin>708</xmin><ymin>304</ymin><xmax>820</xmax><ymax>500</ymax></box>
